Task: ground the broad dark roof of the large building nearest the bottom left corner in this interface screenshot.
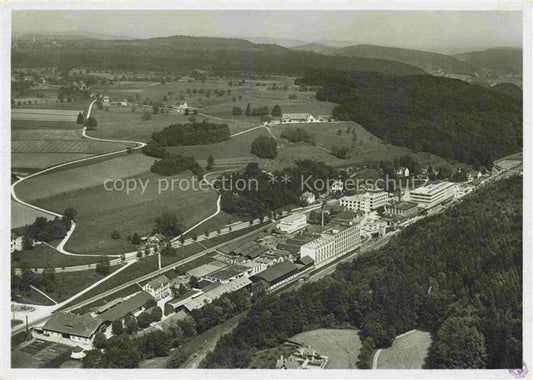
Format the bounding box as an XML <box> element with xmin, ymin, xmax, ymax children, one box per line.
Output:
<box><xmin>43</xmin><ymin>312</ymin><xmax>104</xmax><ymax>338</ymax></box>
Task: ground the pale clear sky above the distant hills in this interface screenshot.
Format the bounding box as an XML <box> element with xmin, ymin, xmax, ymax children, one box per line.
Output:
<box><xmin>12</xmin><ymin>10</ymin><xmax>522</xmax><ymax>53</ymax></box>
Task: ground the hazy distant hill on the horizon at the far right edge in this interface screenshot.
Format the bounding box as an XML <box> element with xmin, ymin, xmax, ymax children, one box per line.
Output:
<box><xmin>454</xmin><ymin>48</ymin><xmax>522</xmax><ymax>75</ymax></box>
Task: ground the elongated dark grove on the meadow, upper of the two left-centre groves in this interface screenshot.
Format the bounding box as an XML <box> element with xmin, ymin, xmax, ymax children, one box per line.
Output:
<box><xmin>152</xmin><ymin>121</ymin><xmax>230</xmax><ymax>146</ymax></box>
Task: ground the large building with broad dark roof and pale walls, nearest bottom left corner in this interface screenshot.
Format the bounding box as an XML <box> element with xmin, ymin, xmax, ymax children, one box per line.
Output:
<box><xmin>36</xmin><ymin>312</ymin><xmax>104</xmax><ymax>347</ymax></box>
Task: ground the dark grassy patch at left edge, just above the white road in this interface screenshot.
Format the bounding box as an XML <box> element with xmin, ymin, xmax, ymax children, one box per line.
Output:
<box><xmin>11</xmin><ymin>244</ymin><xmax>101</xmax><ymax>269</ymax></box>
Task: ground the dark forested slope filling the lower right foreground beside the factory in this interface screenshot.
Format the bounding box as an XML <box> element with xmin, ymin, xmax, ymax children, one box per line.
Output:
<box><xmin>203</xmin><ymin>177</ymin><xmax>522</xmax><ymax>368</ymax></box>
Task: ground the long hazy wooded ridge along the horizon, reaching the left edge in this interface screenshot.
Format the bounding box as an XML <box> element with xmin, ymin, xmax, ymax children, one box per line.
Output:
<box><xmin>11</xmin><ymin>36</ymin><xmax>424</xmax><ymax>75</ymax></box>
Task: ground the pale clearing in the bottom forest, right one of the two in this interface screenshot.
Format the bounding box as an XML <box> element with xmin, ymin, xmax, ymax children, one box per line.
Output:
<box><xmin>377</xmin><ymin>330</ymin><xmax>431</xmax><ymax>369</ymax></box>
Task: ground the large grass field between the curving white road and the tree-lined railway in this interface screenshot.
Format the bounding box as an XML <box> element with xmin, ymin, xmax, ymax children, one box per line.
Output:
<box><xmin>36</xmin><ymin>169</ymin><xmax>218</xmax><ymax>254</ymax></box>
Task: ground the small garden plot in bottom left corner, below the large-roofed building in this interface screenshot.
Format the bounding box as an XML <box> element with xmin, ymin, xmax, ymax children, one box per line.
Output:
<box><xmin>11</xmin><ymin>339</ymin><xmax>72</xmax><ymax>368</ymax></box>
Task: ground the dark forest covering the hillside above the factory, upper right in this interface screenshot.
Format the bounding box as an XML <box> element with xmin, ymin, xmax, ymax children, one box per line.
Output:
<box><xmin>299</xmin><ymin>70</ymin><xmax>522</xmax><ymax>169</ymax></box>
